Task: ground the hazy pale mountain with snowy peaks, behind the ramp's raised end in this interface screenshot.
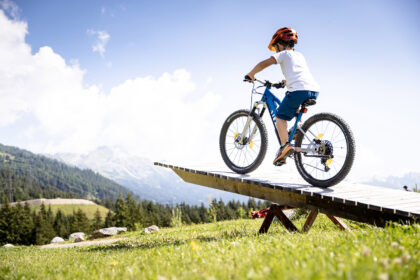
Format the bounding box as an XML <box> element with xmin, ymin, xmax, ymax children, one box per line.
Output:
<box><xmin>53</xmin><ymin>147</ymin><xmax>248</xmax><ymax>205</ymax></box>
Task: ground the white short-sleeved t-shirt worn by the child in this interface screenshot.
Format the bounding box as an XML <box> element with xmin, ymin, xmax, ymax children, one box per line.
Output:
<box><xmin>272</xmin><ymin>50</ymin><xmax>319</xmax><ymax>92</ymax></box>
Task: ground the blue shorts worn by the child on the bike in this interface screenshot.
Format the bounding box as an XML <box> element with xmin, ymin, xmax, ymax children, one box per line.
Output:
<box><xmin>276</xmin><ymin>90</ymin><xmax>319</xmax><ymax>121</ymax></box>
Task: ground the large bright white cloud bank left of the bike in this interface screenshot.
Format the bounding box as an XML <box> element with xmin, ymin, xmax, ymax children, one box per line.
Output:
<box><xmin>0</xmin><ymin>11</ymin><xmax>220</xmax><ymax>162</ymax></box>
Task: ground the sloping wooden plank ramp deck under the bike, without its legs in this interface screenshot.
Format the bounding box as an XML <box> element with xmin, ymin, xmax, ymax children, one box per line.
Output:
<box><xmin>155</xmin><ymin>162</ymin><xmax>420</xmax><ymax>226</ymax></box>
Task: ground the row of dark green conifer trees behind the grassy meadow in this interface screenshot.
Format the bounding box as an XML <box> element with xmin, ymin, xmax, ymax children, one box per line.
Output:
<box><xmin>0</xmin><ymin>193</ymin><xmax>268</xmax><ymax>245</ymax></box>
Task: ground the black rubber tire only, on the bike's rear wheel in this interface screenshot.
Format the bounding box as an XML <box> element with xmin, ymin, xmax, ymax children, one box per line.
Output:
<box><xmin>294</xmin><ymin>113</ymin><xmax>356</xmax><ymax>188</ymax></box>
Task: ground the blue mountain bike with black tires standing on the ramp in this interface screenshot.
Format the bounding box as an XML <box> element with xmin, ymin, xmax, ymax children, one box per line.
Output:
<box><xmin>219</xmin><ymin>79</ymin><xmax>356</xmax><ymax>187</ymax></box>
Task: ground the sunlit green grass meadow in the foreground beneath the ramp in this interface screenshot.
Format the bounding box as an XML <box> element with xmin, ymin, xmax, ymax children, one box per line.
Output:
<box><xmin>0</xmin><ymin>215</ymin><xmax>420</xmax><ymax>279</ymax></box>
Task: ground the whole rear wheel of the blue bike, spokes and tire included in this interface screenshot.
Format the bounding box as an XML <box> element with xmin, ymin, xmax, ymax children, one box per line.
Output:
<box><xmin>295</xmin><ymin>113</ymin><xmax>356</xmax><ymax>187</ymax></box>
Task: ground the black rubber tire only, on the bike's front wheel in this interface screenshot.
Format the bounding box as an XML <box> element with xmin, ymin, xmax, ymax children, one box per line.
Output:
<box><xmin>219</xmin><ymin>109</ymin><xmax>268</xmax><ymax>174</ymax></box>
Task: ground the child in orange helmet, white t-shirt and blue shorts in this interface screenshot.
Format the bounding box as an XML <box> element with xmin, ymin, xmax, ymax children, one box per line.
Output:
<box><xmin>245</xmin><ymin>27</ymin><xmax>319</xmax><ymax>166</ymax></box>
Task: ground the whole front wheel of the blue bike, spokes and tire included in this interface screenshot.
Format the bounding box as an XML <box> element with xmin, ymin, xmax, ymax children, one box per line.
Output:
<box><xmin>219</xmin><ymin>110</ymin><xmax>267</xmax><ymax>174</ymax></box>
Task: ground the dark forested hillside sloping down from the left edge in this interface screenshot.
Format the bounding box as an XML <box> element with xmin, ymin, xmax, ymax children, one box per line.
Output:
<box><xmin>0</xmin><ymin>144</ymin><xmax>129</xmax><ymax>201</ymax></box>
